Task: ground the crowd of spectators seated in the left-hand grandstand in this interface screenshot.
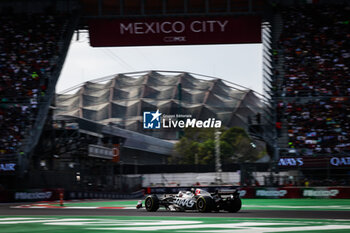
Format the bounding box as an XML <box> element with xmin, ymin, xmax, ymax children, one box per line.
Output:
<box><xmin>0</xmin><ymin>13</ymin><xmax>64</xmax><ymax>155</ymax></box>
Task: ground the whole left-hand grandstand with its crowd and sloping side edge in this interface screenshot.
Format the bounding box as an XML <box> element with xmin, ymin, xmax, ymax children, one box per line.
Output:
<box><xmin>0</xmin><ymin>1</ymin><xmax>78</xmax><ymax>180</ymax></box>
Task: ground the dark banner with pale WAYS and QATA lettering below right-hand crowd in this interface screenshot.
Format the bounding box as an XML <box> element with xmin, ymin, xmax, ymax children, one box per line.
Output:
<box><xmin>278</xmin><ymin>156</ymin><xmax>350</xmax><ymax>168</ymax></box>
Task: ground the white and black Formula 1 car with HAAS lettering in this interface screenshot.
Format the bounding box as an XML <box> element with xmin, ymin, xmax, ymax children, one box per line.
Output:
<box><xmin>136</xmin><ymin>189</ymin><xmax>242</xmax><ymax>212</ymax></box>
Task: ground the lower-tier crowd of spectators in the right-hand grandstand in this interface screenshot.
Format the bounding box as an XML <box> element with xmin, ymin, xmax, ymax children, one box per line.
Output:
<box><xmin>278</xmin><ymin>98</ymin><xmax>350</xmax><ymax>155</ymax></box>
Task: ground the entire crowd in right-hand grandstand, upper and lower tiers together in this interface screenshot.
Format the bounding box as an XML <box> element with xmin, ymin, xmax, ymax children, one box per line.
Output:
<box><xmin>276</xmin><ymin>4</ymin><xmax>350</xmax><ymax>155</ymax></box>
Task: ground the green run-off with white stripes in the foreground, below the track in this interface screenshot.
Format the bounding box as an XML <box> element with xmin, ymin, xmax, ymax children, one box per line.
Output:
<box><xmin>0</xmin><ymin>216</ymin><xmax>350</xmax><ymax>233</ymax></box>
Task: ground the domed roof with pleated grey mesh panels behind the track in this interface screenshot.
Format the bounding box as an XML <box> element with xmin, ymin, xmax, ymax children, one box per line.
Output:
<box><xmin>55</xmin><ymin>71</ymin><xmax>263</xmax><ymax>139</ymax></box>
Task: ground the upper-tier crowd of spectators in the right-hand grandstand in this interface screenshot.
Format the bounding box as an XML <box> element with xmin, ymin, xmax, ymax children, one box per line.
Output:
<box><xmin>279</xmin><ymin>5</ymin><xmax>350</xmax><ymax>97</ymax></box>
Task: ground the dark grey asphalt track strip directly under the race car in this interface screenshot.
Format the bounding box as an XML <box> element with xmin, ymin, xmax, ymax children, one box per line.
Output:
<box><xmin>0</xmin><ymin>204</ymin><xmax>350</xmax><ymax>219</ymax></box>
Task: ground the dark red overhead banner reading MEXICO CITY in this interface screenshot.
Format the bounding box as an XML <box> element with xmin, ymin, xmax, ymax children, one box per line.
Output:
<box><xmin>89</xmin><ymin>16</ymin><xmax>261</xmax><ymax>47</ymax></box>
